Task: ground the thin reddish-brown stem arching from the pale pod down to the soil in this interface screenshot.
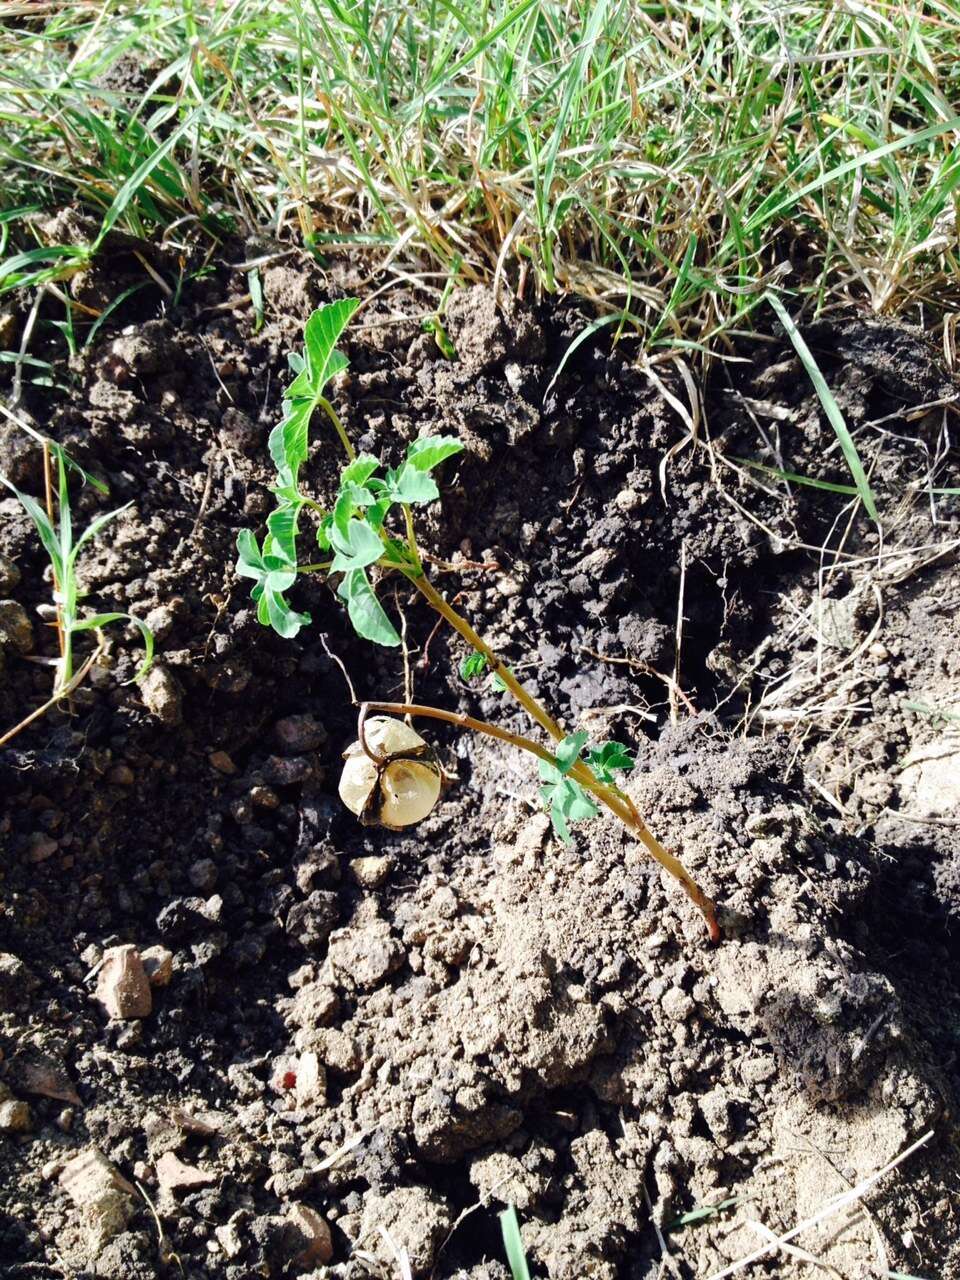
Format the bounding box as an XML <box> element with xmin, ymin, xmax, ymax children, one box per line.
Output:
<box><xmin>358</xmin><ymin>703</ymin><xmax>721</xmax><ymax>942</ymax></box>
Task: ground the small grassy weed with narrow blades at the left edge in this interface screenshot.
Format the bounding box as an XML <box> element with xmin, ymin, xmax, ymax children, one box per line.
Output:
<box><xmin>0</xmin><ymin>424</ymin><xmax>154</xmax><ymax>745</ymax></box>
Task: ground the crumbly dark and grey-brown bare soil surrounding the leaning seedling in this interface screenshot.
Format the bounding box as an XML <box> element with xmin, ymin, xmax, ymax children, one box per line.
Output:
<box><xmin>0</xmin><ymin>244</ymin><xmax>960</xmax><ymax>1280</ymax></box>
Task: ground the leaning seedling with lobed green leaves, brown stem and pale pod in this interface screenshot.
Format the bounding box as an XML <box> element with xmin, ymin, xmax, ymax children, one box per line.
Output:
<box><xmin>237</xmin><ymin>298</ymin><xmax>719</xmax><ymax>941</ymax></box>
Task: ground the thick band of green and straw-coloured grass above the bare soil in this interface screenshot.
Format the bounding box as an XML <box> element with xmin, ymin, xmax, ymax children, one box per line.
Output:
<box><xmin>0</xmin><ymin>0</ymin><xmax>960</xmax><ymax>347</ymax></box>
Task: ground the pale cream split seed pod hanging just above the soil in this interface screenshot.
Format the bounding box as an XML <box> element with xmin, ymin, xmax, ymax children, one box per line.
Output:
<box><xmin>339</xmin><ymin>716</ymin><xmax>442</xmax><ymax>831</ymax></box>
